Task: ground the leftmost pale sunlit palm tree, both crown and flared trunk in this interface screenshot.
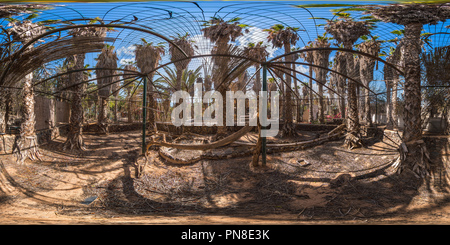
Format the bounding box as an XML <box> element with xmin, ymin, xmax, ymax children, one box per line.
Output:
<box><xmin>8</xmin><ymin>20</ymin><xmax>45</xmax><ymax>163</ymax></box>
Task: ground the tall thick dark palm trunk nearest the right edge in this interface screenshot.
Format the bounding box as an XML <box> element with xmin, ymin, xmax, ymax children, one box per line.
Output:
<box><xmin>399</xmin><ymin>23</ymin><xmax>429</xmax><ymax>177</ymax></box>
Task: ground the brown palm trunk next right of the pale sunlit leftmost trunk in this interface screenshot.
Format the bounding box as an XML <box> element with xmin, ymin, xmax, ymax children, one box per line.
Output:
<box><xmin>64</xmin><ymin>54</ymin><xmax>85</xmax><ymax>150</ymax></box>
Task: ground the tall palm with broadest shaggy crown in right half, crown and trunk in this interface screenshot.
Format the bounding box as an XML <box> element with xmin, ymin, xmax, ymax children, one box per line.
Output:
<box><xmin>325</xmin><ymin>14</ymin><xmax>370</xmax><ymax>149</ymax></box>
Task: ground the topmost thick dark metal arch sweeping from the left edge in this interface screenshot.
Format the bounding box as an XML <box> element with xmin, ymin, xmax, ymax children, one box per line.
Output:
<box><xmin>0</xmin><ymin>24</ymin><xmax>188</xmax><ymax>84</ymax></box>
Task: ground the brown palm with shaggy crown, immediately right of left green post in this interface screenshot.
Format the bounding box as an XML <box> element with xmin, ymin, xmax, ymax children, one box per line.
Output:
<box><xmin>135</xmin><ymin>38</ymin><xmax>165</xmax><ymax>131</ymax></box>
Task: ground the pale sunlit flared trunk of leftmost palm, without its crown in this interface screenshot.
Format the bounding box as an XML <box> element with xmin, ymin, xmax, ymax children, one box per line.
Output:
<box><xmin>13</xmin><ymin>73</ymin><xmax>40</xmax><ymax>164</ymax></box>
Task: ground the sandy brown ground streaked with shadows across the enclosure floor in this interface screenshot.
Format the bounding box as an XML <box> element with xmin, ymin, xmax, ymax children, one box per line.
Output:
<box><xmin>0</xmin><ymin>129</ymin><xmax>450</xmax><ymax>224</ymax></box>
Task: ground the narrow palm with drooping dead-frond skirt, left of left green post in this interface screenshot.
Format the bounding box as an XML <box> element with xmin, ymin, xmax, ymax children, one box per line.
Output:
<box><xmin>96</xmin><ymin>45</ymin><xmax>118</xmax><ymax>134</ymax></box>
